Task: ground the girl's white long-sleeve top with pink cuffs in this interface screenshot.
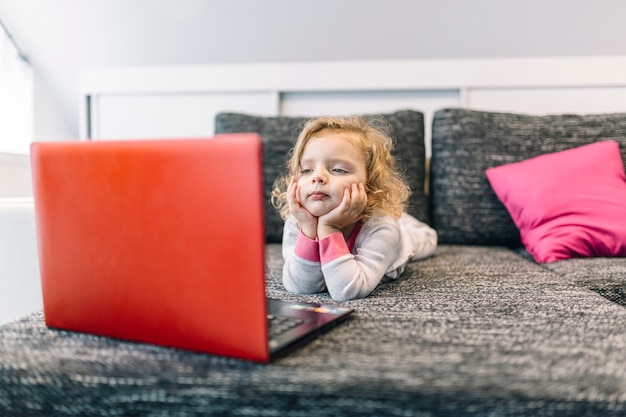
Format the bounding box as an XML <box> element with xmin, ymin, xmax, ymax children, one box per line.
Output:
<box><xmin>282</xmin><ymin>213</ymin><xmax>437</xmax><ymax>301</ymax></box>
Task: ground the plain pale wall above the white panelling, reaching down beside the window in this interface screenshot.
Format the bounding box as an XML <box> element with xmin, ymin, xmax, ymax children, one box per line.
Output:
<box><xmin>0</xmin><ymin>0</ymin><xmax>626</xmax><ymax>140</ymax></box>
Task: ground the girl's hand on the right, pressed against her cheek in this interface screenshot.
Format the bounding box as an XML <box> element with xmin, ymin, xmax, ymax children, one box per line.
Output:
<box><xmin>317</xmin><ymin>183</ymin><xmax>367</xmax><ymax>239</ymax></box>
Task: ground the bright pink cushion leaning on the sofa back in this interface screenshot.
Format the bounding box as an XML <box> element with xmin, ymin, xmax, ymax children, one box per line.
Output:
<box><xmin>486</xmin><ymin>141</ymin><xmax>626</xmax><ymax>263</ymax></box>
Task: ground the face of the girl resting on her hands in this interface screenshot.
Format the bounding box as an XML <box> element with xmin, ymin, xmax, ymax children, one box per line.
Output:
<box><xmin>297</xmin><ymin>132</ymin><xmax>367</xmax><ymax>217</ymax></box>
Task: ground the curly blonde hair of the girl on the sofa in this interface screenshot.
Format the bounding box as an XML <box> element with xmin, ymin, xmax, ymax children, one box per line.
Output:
<box><xmin>271</xmin><ymin>112</ymin><xmax>411</xmax><ymax>220</ymax></box>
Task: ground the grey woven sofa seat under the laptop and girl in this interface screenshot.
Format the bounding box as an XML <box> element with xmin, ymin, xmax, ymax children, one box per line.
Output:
<box><xmin>0</xmin><ymin>244</ymin><xmax>626</xmax><ymax>416</ymax></box>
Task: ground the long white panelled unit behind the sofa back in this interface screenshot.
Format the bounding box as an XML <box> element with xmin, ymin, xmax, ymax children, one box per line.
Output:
<box><xmin>81</xmin><ymin>56</ymin><xmax>626</xmax><ymax>149</ymax></box>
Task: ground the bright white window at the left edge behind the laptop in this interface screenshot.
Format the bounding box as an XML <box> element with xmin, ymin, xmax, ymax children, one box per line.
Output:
<box><xmin>0</xmin><ymin>17</ymin><xmax>34</xmax><ymax>154</ymax></box>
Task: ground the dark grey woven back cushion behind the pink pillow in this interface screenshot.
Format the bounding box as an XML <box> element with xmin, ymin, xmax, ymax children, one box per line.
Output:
<box><xmin>430</xmin><ymin>109</ymin><xmax>626</xmax><ymax>247</ymax></box>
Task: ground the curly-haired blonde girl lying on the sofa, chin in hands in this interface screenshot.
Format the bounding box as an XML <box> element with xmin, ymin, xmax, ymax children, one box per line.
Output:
<box><xmin>272</xmin><ymin>116</ymin><xmax>437</xmax><ymax>301</ymax></box>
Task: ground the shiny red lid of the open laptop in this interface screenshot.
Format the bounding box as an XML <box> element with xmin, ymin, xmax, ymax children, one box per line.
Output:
<box><xmin>31</xmin><ymin>134</ymin><xmax>269</xmax><ymax>362</ymax></box>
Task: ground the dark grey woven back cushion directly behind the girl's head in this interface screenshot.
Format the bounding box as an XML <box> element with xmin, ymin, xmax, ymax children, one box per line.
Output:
<box><xmin>215</xmin><ymin>110</ymin><xmax>428</xmax><ymax>242</ymax></box>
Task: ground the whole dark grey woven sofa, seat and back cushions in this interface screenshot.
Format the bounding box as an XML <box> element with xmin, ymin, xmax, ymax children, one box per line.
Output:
<box><xmin>0</xmin><ymin>109</ymin><xmax>626</xmax><ymax>416</ymax></box>
